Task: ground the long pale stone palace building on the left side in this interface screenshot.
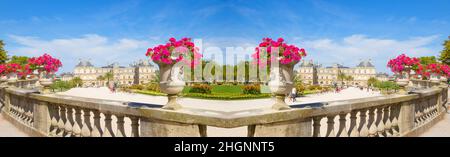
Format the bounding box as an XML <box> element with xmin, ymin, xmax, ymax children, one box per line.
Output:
<box><xmin>73</xmin><ymin>60</ymin><xmax>156</xmax><ymax>86</ymax></box>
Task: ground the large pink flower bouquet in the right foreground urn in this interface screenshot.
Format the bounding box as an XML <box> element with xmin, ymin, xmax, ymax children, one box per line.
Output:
<box><xmin>252</xmin><ymin>38</ymin><xmax>306</xmax><ymax>66</ymax></box>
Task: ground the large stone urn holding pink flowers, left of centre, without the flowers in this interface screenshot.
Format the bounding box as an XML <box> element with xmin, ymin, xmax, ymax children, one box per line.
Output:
<box><xmin>157</xmin><ymin>63</ymin><xmax>186</xmax><ymax>110</ymax></box>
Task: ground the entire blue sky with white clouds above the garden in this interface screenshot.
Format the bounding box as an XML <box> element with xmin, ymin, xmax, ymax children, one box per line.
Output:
<box><xmin>0</xmin><ymin>0</ymin><xmax>450</xmax><ymax>72</ymax></box>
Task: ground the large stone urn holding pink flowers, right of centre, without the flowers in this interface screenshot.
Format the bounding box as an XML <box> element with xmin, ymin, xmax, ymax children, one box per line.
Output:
<box><xmin>268</xmin><ymin>62</ymin><xmax>298</xmax><ymax>110</ymax></box>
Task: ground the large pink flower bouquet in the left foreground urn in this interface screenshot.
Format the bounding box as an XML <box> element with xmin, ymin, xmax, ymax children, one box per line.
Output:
<box><xmin>145</xmin><ymin>38</ymin><xmax>202</xmax><ymax>67</ymax></box>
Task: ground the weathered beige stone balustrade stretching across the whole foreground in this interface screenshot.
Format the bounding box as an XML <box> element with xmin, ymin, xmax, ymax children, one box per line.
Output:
<box><xmin>0</xmin><ymin>80</ymin><xmax>448</xmax><ymax>137</ymax></box>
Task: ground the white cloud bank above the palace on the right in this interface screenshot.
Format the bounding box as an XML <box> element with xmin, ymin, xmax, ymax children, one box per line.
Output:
<box><xmin>297</xmin><ymin>34</ymin><xmax>438</xmax><ymax>72</ymax></box>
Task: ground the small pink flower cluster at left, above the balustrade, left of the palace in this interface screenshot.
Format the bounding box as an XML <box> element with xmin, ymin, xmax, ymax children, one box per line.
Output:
<box><xmin>27</xmin><ymin>53</ymin><xmax>62</xmax><ymax>74</ymax></box>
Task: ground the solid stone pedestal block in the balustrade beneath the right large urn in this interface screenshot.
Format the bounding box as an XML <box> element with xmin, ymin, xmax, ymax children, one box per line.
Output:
<box><xmin>249</xmin><ymin>118</ymin><xmax>312</xmax><ymax>137</ymax></box>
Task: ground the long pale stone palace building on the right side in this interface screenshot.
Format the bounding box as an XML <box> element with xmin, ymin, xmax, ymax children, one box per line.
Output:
<box><xmin>296</xmin><ymin>60</ymin><xmax>377</xmax><ymax>86</ymax></box>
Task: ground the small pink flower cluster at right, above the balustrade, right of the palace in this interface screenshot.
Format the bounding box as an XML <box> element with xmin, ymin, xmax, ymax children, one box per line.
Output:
<box><xmin>387</xmin><ymin>54</ymin><xmax>423</xmax><ymax>74</ymax></box>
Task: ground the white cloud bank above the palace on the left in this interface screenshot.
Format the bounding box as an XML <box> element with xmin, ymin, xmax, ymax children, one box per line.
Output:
<box><xmin>10</xmin><ymin>34</ymin><xmax>155</xmax><ymax>71</ymax></box>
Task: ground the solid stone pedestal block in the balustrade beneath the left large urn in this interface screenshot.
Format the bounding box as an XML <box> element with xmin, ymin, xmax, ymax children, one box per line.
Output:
<box><xmin>140</xmin><ymin>119</ymin><xmax>206</xmax><ymax>137</ymax></box>
